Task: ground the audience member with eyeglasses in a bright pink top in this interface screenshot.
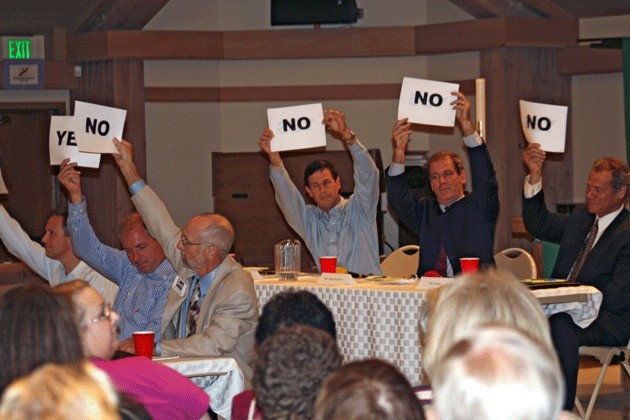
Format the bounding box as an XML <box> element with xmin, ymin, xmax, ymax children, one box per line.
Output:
<box><xmin>53</xmin><ymin>280</ymin><xmax>210</xmax><ymax>420</ymax></box>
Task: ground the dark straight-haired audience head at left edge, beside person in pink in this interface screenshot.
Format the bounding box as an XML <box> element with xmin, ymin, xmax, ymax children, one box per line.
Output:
<box><xmin>0</xmin><ymin>285</ymin><xmax>83</xmax><ymax>394</ymax></box>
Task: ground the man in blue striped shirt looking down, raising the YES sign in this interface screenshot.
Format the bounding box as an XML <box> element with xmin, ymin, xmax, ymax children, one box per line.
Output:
<box><xmin>58</xmin><ymin>159</ymin><xmax>177</xmax><ymax>342</ymax></box>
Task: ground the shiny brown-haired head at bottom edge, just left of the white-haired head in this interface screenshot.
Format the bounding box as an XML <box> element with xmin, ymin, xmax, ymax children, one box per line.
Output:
<box><xmin>314</xmin><ymin>359</ymin><xmax>424</xmax><ymax>420</ymax></box>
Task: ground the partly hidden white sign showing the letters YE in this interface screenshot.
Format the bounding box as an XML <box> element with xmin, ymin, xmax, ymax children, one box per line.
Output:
<box><xmin>48</xmin><ymin>116</ymin><xmax>101</xmax><ymax>168</ymax></box>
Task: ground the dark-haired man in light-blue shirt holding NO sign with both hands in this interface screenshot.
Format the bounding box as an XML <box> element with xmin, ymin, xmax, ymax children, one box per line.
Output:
<box><xmin>258</xmin><ymin>109</ymin><xmax>381</xmax><ymax>275</ymax></box>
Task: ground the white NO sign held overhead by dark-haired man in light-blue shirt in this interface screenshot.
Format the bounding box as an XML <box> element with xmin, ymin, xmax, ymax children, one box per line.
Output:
<box><xmin>267</xmin><ymin>104</ymin><xmax>326</xmax><ymax>152</ymax></box>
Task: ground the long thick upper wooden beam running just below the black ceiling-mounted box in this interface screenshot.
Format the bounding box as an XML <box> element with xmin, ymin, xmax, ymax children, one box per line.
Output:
<box><xmin>68</xmin><ymin>17</ymin><xmax>578</xmax><ymax>62</ymax></box>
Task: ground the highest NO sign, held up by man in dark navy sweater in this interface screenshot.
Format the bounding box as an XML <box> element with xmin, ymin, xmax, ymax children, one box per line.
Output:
<box><xmin>398</xmin><ymin>77</ymin><xmax>459</xmax><ymax>127</ymax></box>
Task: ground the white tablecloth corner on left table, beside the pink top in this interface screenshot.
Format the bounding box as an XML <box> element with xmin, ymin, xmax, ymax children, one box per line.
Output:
<box><xmin>154</xmin><ymin>357</ymin><xmax>243</xmax><ymax>419</ymax></box>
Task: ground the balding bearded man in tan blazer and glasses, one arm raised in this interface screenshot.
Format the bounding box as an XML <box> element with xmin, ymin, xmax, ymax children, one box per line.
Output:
<box><xmin>114</xmin><ymin>140</ymin><xmax>258</xmax><ymax>381</ymax></box>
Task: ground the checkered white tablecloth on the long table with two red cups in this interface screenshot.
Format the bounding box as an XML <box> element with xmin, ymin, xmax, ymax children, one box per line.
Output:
<box><xmin>254</xmin><ymin>276</ymin><xmax>602</xmax><ymax>385</ymax></box>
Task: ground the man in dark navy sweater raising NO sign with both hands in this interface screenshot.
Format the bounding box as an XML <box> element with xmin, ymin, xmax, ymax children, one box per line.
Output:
<box><xmin>386</xmin><ymin>92</ymin><xmax>499</xmax><ymax>277</ymax></box>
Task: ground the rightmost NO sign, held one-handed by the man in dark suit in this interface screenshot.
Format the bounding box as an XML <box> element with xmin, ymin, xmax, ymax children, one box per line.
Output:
<box><xmin>519</xmin><ymin>100</ymin><xmax>569</xmax><ymax>153</ymax></box>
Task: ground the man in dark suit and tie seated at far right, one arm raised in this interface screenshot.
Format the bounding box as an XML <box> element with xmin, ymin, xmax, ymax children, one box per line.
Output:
<box><xmin>523</xmin><ymin>143</ymin><xmax>630</xmax><ymax>410</ymax></box>
